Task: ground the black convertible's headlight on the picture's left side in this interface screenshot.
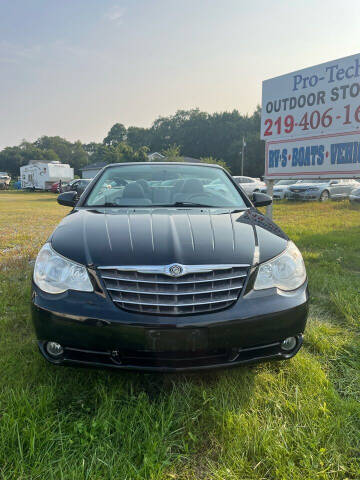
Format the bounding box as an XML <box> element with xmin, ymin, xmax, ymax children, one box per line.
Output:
<box><xmin>34</xmin><ymin>243</ymin><xmax>94</xmax><ymax>293</ymax></box>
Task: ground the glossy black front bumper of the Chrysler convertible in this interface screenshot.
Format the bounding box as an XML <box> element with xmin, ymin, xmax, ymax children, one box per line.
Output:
<box><xmin>32</xmin><ymin>283</ymin><xmax>308</xmax><ymax>372</ymax></box>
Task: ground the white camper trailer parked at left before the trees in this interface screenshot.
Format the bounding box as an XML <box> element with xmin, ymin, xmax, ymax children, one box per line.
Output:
<box><xmin>20</xmin><ymin>161</ymin><xmax>74</xmax><ymax>190</ymax></box>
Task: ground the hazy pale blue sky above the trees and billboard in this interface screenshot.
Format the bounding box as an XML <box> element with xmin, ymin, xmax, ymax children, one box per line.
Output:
<box><xmin>0</xmin><ymin>0</ymin><xmax>360</xmax><ymax>149</ymax></box>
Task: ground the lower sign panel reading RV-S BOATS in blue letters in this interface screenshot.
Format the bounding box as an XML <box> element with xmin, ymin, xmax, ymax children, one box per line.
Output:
<box><xmin>265</xmin><ymin>133</ymin><xmax>360</xmax><ymax>179</ymax></box>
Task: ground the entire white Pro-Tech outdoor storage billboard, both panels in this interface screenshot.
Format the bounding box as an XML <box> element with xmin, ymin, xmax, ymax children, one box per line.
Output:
<box><xmin>261</xmin><ymin>54</ymin><xmax>360</xmax><ymax>178</ymax></box>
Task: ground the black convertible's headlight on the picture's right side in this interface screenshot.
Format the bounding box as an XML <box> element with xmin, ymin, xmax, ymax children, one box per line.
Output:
<box><xmin>254</xmin><ymin>242</ymin><xmax>306</xmax><ymax>291</ymax></box>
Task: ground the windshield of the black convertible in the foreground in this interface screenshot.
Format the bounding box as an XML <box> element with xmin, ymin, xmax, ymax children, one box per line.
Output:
<box><xmin>85</xmin><ymin>164</ymin><xmax>247</xmax><ymax>208</ymax></box>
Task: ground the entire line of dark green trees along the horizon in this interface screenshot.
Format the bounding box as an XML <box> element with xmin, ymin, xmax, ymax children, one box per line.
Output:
<box><xmin>0</xmin><ymin>107</ymin><xmax>264</xmax><ymax>177</ymax></box>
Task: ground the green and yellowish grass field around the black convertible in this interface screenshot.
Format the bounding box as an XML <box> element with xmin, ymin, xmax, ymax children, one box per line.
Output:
<box><xmin>0</xmin><ymin>192</ymin><xmax>360</xmax><ymax>480</ymax></box>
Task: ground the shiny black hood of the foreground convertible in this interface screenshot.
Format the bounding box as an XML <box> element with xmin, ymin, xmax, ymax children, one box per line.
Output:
<box><xmin>50</xmin><ymin>208</ymin><xmax>288</xmax><ymax>266</ymax></box>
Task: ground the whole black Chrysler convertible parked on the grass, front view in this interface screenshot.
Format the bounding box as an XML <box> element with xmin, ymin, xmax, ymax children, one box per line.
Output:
<box><xmin>32</xmin><ymin>162</ymin><xmax>308</xmax><ymax>371</ymax></box>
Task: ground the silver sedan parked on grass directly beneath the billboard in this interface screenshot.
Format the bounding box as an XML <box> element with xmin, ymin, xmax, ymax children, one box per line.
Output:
<box><xmin>287</xmin><ymin>179</ymin><xmax>358</xmax><ymax>202</ymax></box>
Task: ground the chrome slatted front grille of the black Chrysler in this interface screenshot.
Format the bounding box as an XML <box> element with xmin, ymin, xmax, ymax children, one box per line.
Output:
<box><xmin>99</xmin><ymin>265</ymin><xmax>249</xmax><ymax>315</ymax></box>
